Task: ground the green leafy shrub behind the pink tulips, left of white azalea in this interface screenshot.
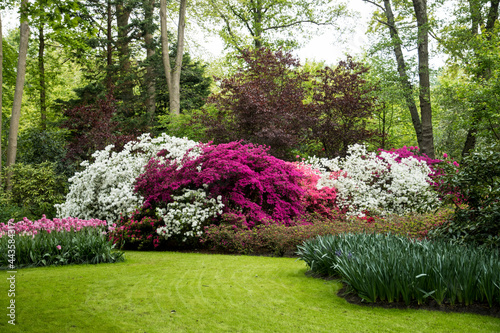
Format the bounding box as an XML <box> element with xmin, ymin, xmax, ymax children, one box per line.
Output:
<box><xmin>5</xmin><ymin>162</ymin><xmax>66</xmax><ymax>218</ymax></box>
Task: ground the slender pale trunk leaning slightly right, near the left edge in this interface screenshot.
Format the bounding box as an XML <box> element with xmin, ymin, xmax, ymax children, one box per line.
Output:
<box><xmin>6</xmin><ymin>0</ymin><xmax>30</xmax><ymax>191</ymax></box>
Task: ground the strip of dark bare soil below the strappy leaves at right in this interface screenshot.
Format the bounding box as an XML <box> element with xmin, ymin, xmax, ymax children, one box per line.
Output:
<box><xmin>306</xmin><ymin>271</ymin><xmax>500</xmax><ymax>318</ymax></box>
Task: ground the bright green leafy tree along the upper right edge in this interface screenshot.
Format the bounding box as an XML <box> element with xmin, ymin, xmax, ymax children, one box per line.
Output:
<box><xmin>438</xmin><ymin>0</ymin><xmax>500</xmax><ymax>157</ymax></box>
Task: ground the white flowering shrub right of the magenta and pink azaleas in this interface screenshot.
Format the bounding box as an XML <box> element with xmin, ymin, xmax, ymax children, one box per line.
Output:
<box><xmin>305</xmin><ymin>144</ymin><xmax>439</xmax><ymax>216</ymax></box>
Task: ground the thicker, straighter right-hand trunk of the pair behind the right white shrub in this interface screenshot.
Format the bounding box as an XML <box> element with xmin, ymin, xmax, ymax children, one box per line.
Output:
<box><xmin>413</xmin><ymin>0</ymin><xmax>434</xmax><ymax>158</ymax></box>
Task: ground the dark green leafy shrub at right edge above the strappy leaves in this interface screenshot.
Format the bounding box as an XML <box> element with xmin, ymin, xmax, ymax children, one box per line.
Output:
<box><xmin>431</xmin><ymin>145</ymin><xmax>500</xmax><ymax>248</ymax></box>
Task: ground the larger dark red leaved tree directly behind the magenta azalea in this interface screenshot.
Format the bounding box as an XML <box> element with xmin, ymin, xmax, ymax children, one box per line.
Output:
<box><xmin>201</xmin><ymin>48</ymin><xmax>311</xmax><ymax>158</ymax></box>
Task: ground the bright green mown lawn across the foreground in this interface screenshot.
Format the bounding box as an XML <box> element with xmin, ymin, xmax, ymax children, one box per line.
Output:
<box><xmin>0</xmin><ymin>252</ymin><xmax>500</xmax><ymax>333</ymax></box>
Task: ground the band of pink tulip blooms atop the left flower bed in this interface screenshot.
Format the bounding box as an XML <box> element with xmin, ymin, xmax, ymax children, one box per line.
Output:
<box><xmin>0</xmin><ymin>215</ymin><xmax>116</xmax><ymax>238</ymax></box>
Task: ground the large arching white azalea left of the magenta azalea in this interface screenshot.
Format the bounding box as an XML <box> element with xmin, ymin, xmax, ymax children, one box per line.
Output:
<box><xmin>56</xmin><ymin>133</ymin><xmax>200</xmax><ymax>223</ymax></box>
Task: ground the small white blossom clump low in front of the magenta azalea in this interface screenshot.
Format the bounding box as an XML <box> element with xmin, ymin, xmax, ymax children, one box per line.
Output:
<box><xmin>156</xmin><ymin>188</ymin><xmax>224</xmax><ymax>241</ymax></box>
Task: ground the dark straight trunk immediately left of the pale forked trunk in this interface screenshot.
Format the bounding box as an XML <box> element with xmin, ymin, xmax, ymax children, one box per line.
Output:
<box><xmin>144</xmin><ymin>0</ymin><xmax>156</xmax><ymax>124</ymax></box>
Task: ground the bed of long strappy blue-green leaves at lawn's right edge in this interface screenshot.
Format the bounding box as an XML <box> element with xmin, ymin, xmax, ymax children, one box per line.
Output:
<box><xmin>298</xmin><ymin>234</ymin><xmax>500</xmax><ymax>307</ymax></box>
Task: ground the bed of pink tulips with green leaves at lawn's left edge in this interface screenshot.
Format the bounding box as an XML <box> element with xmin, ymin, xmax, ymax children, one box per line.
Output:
<box><xmin>0</xmin><ymin>216</ymin><xmax>124</xmax><ymax>269</ymax></box>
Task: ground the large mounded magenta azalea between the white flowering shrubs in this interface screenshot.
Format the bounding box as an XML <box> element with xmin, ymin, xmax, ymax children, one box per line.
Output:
<box><xmin>135</xmin><ymin>142</ymin><xmax>304</xmax><ymax>227</ymax></box>
